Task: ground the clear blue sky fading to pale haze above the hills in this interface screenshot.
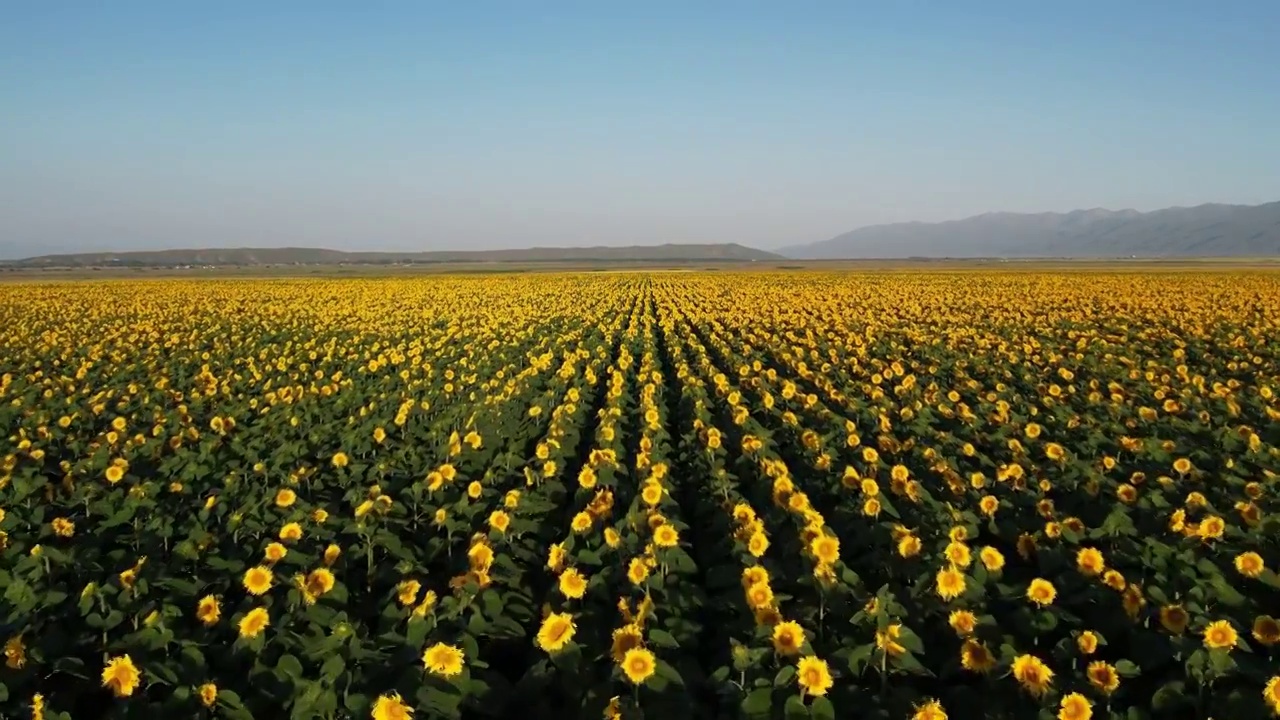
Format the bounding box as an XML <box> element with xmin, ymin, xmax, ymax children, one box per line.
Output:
<box><xmin>0</xmin><ymin>0</ymin><xmax>1280</xmax><ymax>258</ymax></box>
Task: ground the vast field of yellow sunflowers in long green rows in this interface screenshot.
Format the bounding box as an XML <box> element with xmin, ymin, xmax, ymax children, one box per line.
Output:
<box><xmin>0</xmin><ymin>270</ymin><xmax>1280</xmax><ymax>720</ymax></box>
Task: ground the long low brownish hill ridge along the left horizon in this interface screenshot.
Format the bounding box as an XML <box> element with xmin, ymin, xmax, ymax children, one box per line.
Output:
<box><xmin>0</xmin><ymin>243</ymin><xmax>781</xmax><ymax>268</ymax></box>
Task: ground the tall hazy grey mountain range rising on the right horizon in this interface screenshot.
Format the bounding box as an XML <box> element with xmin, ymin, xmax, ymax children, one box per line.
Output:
<box><xmin>781</xmin><ymin>202</ymin><xmax>1280</xmax><ymax>259</ymax></box>
